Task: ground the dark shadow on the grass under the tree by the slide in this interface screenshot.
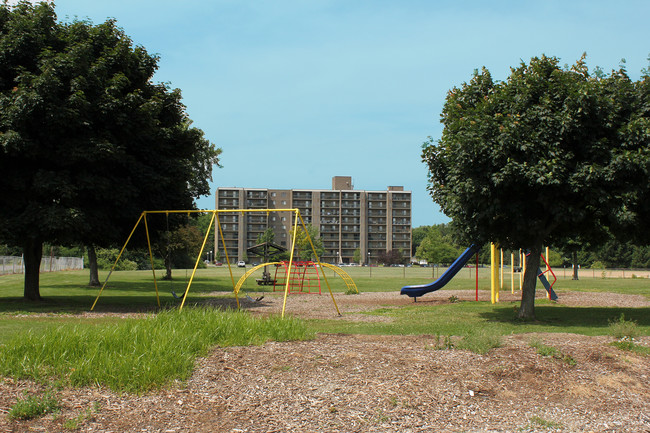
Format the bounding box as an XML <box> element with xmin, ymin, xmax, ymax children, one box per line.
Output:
<box><xmin>479</xmin><ymin>305</ymin><xmax>650</xmax><ymax>328</ymax></box>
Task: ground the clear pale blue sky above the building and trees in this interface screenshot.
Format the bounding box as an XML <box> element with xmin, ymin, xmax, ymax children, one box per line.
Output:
<box><xmin>20</xmin><ymin>0</ymin><xmax>650</xmax><ymax>227</ymax></box>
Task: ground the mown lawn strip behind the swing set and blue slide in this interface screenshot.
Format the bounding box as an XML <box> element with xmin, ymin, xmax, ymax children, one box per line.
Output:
<box><xmin>0</xmin><ymin>266</ymin><xmax>650</xmax><ymax>312</ymax></box>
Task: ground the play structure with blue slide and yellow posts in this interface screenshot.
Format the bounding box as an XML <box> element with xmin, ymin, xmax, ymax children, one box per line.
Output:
<box><xmin>400</xmin><ymin>243</ymin><xmax>558</xmax><ymax>304</ymax></box>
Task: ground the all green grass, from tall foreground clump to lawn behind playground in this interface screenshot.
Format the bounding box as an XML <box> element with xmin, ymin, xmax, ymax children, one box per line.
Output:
<box><xmin>0</xmin><ymin>267</ymin><xmax>650</xmax><ymax>393</ymax></box>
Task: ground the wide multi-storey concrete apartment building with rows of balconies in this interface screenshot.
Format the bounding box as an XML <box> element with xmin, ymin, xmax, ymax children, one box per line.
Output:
<box><xmin>215</xmin><ymin>176</ymin><xmax>411</xmax><ymax>263</ymax></box>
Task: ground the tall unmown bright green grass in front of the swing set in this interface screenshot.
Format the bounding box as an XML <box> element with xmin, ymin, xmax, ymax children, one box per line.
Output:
<box><xmin>0</xmin><ymin>308</ymin><xmax>312</xmax><ymax>393</ymax></box>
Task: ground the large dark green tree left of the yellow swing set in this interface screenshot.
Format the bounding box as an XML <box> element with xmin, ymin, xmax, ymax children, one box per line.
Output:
<box><xmin>0</xmin><ymin>2</ymin><xmax>220</xmax><ymax>300</ymax></box>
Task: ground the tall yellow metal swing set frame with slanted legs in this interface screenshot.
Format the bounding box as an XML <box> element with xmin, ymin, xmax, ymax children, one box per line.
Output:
<box><xmin>90</xmin><ymin>209</ymin><xmax>346</xmax><ymax>317</ymax></box>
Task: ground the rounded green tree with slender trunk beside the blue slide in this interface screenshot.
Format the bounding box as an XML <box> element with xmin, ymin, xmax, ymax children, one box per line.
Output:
<box><xmin>423</xmin><ymin>56</ymin><xmax>649</xmax><ymax>318</ymax></box>
